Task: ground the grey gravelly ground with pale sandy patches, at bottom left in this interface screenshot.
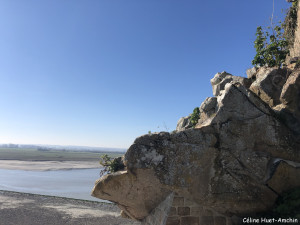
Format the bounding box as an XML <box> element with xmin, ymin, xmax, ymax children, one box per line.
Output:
<box><xmin>0</xmin><ymin>191</ymin><xmax>140</xmax><ymax>225</ymax></box>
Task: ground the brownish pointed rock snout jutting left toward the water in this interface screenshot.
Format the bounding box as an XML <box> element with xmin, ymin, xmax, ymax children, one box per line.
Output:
<box><xmin>92</xmin><ymin>170</ymin><xmax>170</xmax><ymax>220</ymax></box>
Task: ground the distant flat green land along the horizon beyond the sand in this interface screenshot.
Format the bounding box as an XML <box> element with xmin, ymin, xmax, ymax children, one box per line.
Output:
<box><xmin>0</xmin><ymin>148</ymin><xmax>124</xmax><ymax>162</ymax></box>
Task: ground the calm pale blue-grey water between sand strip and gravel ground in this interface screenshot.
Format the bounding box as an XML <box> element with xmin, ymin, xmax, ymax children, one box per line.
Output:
<box><xmin>0</xmin><ymin>169</ymin><xmax>103</xmax><ymax>201</ymax></box>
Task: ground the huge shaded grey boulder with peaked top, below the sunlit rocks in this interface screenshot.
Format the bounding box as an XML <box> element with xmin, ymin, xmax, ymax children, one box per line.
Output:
<box><xmin>93</xmin><ymin>83</ymin><xmax>300</xmax><ymax>219</ymax></box>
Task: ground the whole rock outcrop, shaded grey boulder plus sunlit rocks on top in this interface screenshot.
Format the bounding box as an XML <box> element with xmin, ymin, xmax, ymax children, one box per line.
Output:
<box><xmin>93</xmin><ymin>65</ymin><xmax>300</xmax><ymax>223</ymax></box>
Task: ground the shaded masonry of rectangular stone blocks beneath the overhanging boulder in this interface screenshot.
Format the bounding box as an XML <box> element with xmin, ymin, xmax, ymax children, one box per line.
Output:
<box><xmin>166</xmin><ymin>194</ymin><xmax>232</xmax><ymax>225</ymax></box>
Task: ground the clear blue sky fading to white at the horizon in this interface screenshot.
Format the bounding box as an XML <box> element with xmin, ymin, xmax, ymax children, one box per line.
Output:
<box><xmin>0</xmin><ymin>0</ymin><xmax>289</xmax><ymax>148</ymax></box>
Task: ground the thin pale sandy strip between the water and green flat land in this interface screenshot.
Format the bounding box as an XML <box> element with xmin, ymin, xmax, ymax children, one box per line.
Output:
<box><xmin>0</xmin><ymin>160</ymin><xmax>101</xmax><ymax>171</ymax></box>
